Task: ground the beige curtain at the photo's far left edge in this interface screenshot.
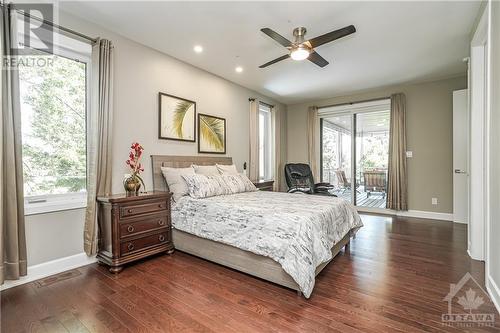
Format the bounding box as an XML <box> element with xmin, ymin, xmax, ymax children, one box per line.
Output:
<box><xmin>0</xmin><ymin>6</ymin><xmax>27</xmax><ymax>284</ymax></box>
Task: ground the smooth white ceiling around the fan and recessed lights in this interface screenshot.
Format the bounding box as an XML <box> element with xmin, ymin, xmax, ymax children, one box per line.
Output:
<box><xmin>60</xmin><ymin>1</ymin><xmax>480</xmax><ymax>104</ymax></box>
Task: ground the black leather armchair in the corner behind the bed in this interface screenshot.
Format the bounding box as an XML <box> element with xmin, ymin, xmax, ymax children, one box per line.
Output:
<box><xmin>285</xmin><ymin>163</ymin><xmax>336</xmax><ymax>197</ymax></box>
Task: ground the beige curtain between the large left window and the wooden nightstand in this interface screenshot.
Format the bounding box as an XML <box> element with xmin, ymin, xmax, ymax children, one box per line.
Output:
<box><xmin>83</xmin><ymin>39</ymin><xmax>113</xmax><ymax>256</ymax></box>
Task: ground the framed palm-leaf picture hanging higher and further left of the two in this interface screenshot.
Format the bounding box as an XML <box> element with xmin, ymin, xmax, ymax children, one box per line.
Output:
<box><xmin>158</xmin><ymin>92</ymin><xmax>196</xmax><ymax>142</ymax></box>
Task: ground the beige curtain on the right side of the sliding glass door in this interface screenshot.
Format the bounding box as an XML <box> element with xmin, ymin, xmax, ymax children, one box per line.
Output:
<box><xmin>387</xmin><ymin>94</ymin><xmax>408</xmax><ymax>210</ymax></box>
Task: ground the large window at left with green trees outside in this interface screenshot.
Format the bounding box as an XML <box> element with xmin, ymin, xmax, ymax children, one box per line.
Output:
<box><xmin>19</xmin><ymin>14</ymin><xmax>91</xmax><ymax>215</ymax></box>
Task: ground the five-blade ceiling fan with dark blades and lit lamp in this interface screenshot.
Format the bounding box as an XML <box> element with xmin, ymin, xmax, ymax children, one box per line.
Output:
<box><xmin>259</xmin><ymin>25</ymin><xmax>356</xmax><ymax>68</ymax></box>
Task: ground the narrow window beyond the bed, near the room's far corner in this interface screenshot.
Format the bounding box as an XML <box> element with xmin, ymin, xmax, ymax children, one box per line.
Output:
<box><xmin>259</xmin><ymin>103</ymin><xmax>274</xmax><ymax>180</ymax></box>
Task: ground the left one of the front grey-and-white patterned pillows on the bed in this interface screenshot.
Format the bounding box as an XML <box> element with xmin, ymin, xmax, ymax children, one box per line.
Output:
<box><xmin>182</xmin><ymin>174</ymin><xmax>227</xmax><ymax>199</ymax></box>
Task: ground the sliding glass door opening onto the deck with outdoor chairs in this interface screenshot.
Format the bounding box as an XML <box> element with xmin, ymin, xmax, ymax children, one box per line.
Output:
<box><xmin>320</xmin><ymin>100</ymin><xmax>390</xmax><ymax>209</ymax></box>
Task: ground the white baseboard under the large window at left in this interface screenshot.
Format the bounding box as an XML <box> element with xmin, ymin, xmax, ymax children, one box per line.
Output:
<box><xmin>0</xmin><ymin>252</ymin><xmax>96</xmax><ymax>290</ymax></box>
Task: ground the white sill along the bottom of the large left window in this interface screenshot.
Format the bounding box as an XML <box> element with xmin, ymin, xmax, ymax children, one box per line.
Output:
<box><xmin>24</xmin><ymin>193</ymin><xmax>87</xmax><ymax>216</ymax></box>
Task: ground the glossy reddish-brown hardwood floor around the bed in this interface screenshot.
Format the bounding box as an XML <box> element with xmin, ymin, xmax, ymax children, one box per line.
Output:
<box><xmin>1</xmin><ymin>215</ymin><xmax>500</xmax><ymax>333</ymax></box>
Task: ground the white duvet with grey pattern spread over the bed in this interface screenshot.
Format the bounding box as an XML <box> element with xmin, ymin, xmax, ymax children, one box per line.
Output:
<box><xmin>172</xmin><ymin>191</ymin><xmax>363</xmax><ymax>298</ymax></box>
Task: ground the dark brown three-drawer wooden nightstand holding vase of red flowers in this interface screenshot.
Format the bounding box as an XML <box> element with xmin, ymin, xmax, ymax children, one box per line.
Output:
<box><xmin>97</xmin><ymin>191</ymin><xmax>174</xmax><ymax>273</ymax></box>
